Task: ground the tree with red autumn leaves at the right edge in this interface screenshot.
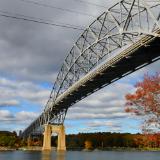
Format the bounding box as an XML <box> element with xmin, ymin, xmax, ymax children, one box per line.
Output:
<box><xmin>125</xmin><ymin>73</ymin><xmax>160</xmax><ymax>132</ymax></box>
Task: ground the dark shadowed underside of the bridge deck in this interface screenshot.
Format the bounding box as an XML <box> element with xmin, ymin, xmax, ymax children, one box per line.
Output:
<box><xmin>53</xmin><ymin>38</ymin><xmax>160</xmax><ymax>110</ymax></box>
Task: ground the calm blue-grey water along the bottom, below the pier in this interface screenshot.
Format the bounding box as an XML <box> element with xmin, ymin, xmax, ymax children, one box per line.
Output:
<box><xmin>0</xmin><ymin>151</ymin><xmax>160</xmax><ymax>160</ymax></box>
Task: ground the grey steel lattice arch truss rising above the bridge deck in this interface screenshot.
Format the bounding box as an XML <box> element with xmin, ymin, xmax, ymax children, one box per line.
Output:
<box><xmin>21</xmin><ymin>0</ymin><xmax>160</xmax><ymax>138</ymax></box>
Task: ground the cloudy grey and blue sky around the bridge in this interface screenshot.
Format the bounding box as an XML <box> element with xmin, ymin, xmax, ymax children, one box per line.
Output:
<box><xmin>0</xmin><ymin>0</ymin><xmax>160</xmax><ymax>134</ymax></box>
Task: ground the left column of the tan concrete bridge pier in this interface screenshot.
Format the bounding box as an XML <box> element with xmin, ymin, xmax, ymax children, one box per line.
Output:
<box><xmin>42</xmin><ymin>125</ymin><xmax>52</xmax><ymax>151</ymax></box>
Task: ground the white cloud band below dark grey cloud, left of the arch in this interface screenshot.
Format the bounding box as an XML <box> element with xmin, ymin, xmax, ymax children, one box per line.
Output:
<box><xmin>0</xmin><ymin>77</ymin><xmax>51</xmax><ymax>106</ymax></box>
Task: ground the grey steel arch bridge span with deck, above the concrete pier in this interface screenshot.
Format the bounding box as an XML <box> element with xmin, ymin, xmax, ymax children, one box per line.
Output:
<box><xmin>22</xmin><ymin>0</ymin><xmax>160</xmax><ymax>137</ymax></box>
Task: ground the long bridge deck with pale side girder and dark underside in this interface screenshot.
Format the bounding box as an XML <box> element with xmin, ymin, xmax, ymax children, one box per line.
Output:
<box><xmin>23</xmin><ymin>30</ymin><xmax>160</xmax><ymax>136</ymax></box>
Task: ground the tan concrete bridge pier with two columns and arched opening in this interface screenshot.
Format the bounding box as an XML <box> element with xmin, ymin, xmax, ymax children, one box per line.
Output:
<box><xmin>42</xmin><ymin>124</ymin><xmax>66</xmax><ymax>151</ymax></box>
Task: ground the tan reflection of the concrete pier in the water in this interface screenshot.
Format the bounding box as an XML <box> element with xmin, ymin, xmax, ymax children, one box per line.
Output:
<box><xmin>41</xmin><ymin>151</ymin><xmax>65</xmax><ymax>160</ymax></box>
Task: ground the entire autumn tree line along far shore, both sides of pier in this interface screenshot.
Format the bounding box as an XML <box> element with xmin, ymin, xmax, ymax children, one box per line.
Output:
<box><xmin>0</xmin><ymin>131</ymin><xmax>160</xmax><ymax>150</ymax></box>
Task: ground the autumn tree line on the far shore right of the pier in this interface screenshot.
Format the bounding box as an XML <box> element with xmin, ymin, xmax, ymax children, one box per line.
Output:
<box><xmin>66</xmin><ymin>132</ymin><xmax>160</xmax><ymax>150</ymax></box>
